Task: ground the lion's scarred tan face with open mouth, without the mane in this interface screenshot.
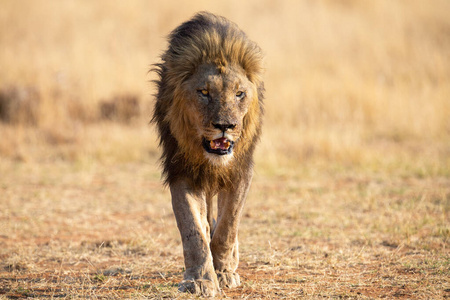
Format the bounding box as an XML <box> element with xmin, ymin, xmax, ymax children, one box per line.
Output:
<box><xmin>184</xmin><ymin>64</ymin><xmax>255</xmax><ymax>164</ymax></box>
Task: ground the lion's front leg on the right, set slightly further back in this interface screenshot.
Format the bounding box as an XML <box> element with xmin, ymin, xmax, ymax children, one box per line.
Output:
<box><xmin>211</xmin><ymin>174</ymin><xmax>252</xmax><ymax>288</ymax></box>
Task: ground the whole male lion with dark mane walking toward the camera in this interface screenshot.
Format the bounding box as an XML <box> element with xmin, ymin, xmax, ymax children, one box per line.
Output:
<box><xmin>152</xmin><ymin>12</ymin><xmax>264</xmax><ymax>296</ymax></box>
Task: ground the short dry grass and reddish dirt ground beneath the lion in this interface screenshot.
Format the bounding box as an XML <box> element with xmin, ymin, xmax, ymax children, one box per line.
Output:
<box><xmin>0</xmin><ymin>162</ymin><xmax>450</xmax><ymax>299</ymax></box>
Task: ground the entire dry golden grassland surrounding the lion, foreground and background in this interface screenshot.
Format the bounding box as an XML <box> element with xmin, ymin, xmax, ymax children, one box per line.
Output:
<box><xmin>0</xmin><ymin>0</ymin><xmax>450</xmax><ymax>299</ymax></box>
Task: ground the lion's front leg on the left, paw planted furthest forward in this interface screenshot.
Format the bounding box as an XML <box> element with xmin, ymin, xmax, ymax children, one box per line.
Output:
<box><xmin>170</xmin><ymin>182</ymin><xmax>220</xmax><ymax>296</ymax></box>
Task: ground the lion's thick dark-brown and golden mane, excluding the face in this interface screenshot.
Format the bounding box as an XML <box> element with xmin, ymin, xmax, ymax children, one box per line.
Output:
<box><xmin>152</xmin><ymin>12</ymin><xmax>264</xmax><ymax>191</ymax></box>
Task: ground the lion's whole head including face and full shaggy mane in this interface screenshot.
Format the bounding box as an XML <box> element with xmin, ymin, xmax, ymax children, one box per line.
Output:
<box><xmin>153</xmin><ymin>13</ymin><xmax>264</xmax><ymax>190</ymax></box>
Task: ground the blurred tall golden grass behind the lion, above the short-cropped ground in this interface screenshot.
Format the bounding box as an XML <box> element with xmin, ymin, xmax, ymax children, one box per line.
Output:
<box><xmin>0</xmin><ymin>0</ymin><xmax>450</xmax><ymax>178</ymax></box>
